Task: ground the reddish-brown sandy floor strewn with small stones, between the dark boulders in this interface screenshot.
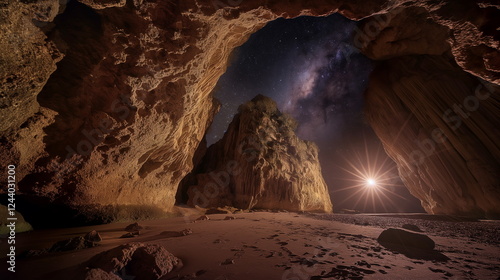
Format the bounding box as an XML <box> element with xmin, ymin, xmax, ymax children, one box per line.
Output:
<box><xmin>0</xmin><ymin>212</ymin><xmax>500</xmax><ymax>280</ymax></box>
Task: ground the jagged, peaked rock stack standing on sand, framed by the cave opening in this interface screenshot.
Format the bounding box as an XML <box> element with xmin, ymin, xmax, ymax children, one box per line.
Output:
<box><xmin>184</xmin><ymin>95</ymin><xmax>332</xmax><ymax>212</ymax></box>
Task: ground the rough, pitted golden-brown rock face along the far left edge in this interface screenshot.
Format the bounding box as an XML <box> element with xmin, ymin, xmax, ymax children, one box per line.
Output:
<box><xmin>0</xmin><ymin>0</ymin><xmax>63</xmax><ymax>183</ymax></box>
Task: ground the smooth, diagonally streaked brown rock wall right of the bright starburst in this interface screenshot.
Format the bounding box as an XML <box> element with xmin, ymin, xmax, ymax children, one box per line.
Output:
<box><xmin>366</xmin><ymin>55</ymin><xmax>500</xmax><ymax>217</ymax></box>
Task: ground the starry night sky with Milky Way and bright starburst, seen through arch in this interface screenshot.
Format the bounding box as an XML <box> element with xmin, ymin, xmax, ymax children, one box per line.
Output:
<box><xmin>207</xmin><ymin>15</ymin><xmax>423</xmax><ymax>212</ymax></box>
